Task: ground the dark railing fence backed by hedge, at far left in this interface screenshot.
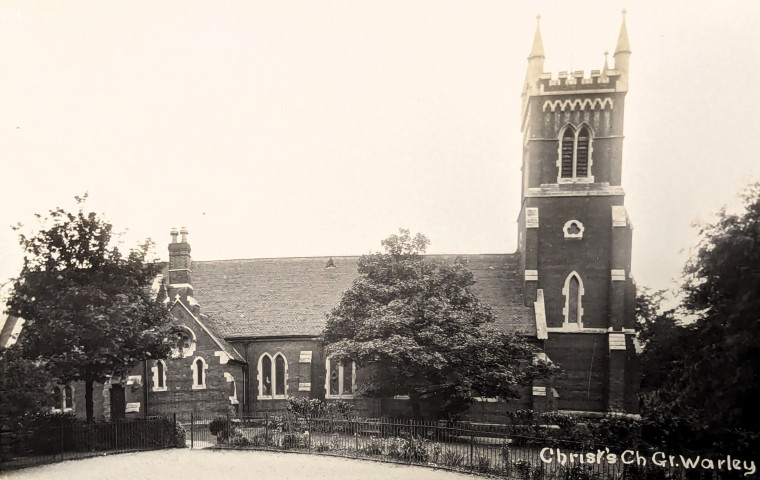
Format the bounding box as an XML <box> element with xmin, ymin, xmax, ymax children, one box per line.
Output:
<box><xmin>0</xmin><ymin>416</ymin><xmax>186</xmax><ymax>470</ymax></box>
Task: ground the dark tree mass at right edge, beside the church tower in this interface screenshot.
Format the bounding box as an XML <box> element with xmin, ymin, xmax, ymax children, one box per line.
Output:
<box><xmin>640</xmin><ymin>185</ymin><xmax>760</xmax><ymax>452</ymax></box>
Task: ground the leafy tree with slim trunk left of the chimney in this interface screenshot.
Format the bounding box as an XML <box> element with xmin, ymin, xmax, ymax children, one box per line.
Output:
<box><xmin>8</xmin><ymin>195</ymin><xmax>170</xmax><ymax>421</ymax></box>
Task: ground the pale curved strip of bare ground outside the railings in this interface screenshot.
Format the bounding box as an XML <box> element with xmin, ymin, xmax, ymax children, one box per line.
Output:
<box><xmin>0</xmin><ymin>449</ymin><xmax>483</xmax><ymax>480</ymax></box>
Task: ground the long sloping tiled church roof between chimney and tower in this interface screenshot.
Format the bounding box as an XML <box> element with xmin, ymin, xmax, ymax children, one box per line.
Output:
<box><xmin>192</xmin><ymin>254</ymin><xmax>536</xmax><ymax>339</ymax></box>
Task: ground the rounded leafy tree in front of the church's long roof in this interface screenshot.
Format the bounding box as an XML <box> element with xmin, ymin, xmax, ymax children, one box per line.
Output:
<box><xmin>324</xmin><ymin>230</ymin><xmax>557</xmax><ymax>418</ymax></box>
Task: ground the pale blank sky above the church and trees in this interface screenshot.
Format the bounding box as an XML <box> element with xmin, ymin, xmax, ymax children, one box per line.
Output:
<box><xmin>0</xmin><ymin>0</ymin><xmax>760</xmax><ymax>300</ymax></box>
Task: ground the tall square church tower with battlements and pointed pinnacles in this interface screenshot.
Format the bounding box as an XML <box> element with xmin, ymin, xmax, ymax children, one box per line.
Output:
<box><xmin>518</xmin><ymin>11</ymin><xmax>638</xmax><ymax>412</ymax></box>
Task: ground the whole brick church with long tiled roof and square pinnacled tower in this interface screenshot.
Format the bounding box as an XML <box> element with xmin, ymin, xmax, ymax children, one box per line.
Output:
<box><xmin>68</xmin><ymin>13</ymin><xmax>639</xmax><ymax>420</ymax></box>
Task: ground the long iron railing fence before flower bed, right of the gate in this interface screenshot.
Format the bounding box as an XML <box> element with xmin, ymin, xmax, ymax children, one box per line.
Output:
<box><xmin>184</xmin><ymin>412</ymin><xmax>732</xmax><ymax>480</ymax></box>
